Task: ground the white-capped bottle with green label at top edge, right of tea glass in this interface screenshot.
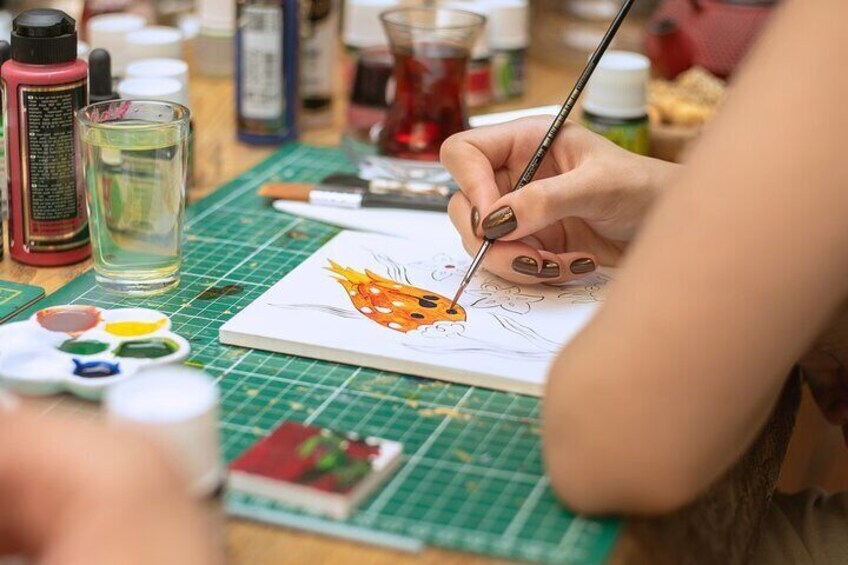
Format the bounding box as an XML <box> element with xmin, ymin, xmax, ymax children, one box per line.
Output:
<box><xmin>486</xmin><ymin>0</ymin><xmax>530</xmax><ymax>102</ymax></box>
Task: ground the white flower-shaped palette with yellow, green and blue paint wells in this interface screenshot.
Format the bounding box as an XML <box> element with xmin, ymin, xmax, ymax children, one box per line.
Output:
<box><xmin>0</xmin><ymin>306</ymin><xmax>190</xmax><ymax>399</ymax></box>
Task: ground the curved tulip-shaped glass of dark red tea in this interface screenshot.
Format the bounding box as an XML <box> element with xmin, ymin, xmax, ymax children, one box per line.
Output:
<box><xmin>378</xmin><ymin>8</ymin><xmax>486</xmax><ymax>161</ymax></box>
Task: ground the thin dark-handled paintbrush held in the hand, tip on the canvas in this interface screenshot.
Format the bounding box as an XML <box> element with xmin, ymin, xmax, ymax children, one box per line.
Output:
<box><xmin>451</xmin><ymin>0</ymin><xmax>634</xmax><ymax>308</ymax></box>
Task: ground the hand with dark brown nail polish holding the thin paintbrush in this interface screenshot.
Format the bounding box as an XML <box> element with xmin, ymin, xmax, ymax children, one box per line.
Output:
<box><xmin>442</xmin><ymin>116</ymin><xmax>681</xmax><ymax>284</ymax></box>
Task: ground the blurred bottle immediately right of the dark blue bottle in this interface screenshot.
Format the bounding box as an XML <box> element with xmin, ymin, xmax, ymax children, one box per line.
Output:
<box><xmin>300</xmin><ymin>0</ymin><xmax>339</xmax><ymax>127</ymax></box>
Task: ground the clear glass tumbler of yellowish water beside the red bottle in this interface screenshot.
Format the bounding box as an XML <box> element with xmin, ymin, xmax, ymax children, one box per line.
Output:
<box><xmin>77</xmin><ymin>100</ymin><xmax>189</xmax><ymax>296</ymax></box>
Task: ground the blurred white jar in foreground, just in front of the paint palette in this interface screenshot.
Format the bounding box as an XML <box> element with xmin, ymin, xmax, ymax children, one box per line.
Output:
<box><xmin>103</xmin><ymin>366</ymin><xmax>224</xmax><ymax>497</ymax></box>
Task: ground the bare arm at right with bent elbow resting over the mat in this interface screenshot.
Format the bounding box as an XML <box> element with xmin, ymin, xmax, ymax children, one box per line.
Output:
<box><xmin>543</xmin><ymin>0</ymin><xmax>848</xmax><ymax>512</ymax></box>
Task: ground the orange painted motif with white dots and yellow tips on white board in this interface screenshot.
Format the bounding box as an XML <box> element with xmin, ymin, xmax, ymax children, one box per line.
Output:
<box><xmin>327</xmin><ymin>261</ymin><xmax>465</xmax><ymax>333</ymax></box>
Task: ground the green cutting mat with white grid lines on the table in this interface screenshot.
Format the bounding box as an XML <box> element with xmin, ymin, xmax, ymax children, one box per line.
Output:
<box><xmin>18</xmin><ymin>145</ymin><xmax>619</xmax><ymax>564</ymax></box>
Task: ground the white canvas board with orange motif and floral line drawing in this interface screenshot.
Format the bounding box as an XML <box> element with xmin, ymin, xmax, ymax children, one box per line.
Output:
<box><xmin>220</xmin><ymin>232</ymin><xmax>611</xmax><ymax>395</ymax></box>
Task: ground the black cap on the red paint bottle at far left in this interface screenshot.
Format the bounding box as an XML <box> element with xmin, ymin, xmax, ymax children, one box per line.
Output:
<box><xmin>12</xmin><ymin>8</ymin><xmax>77</xmax><ymax>65</ymax></box>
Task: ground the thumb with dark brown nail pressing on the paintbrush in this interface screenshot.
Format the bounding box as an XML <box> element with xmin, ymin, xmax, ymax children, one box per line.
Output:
<box><xmin>481</xmin><ymin>169</ymin><xmax>586</xmax><ymax>241</ymax></box>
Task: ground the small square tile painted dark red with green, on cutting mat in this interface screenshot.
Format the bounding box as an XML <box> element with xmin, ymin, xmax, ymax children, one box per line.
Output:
<box><xmin>228</xmin><ymin>422</ymin><xmax>402</xmax><ymax>519</ymax></box>
